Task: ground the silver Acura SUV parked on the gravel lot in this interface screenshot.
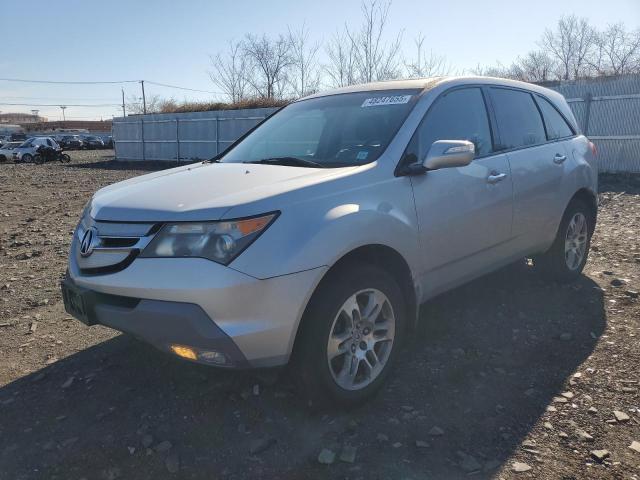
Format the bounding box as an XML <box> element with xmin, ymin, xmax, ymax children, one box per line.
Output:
<box><xmin>62</xmin><ymin>77</ymin><xmax>597</xmax><ymax>404</ymax></box>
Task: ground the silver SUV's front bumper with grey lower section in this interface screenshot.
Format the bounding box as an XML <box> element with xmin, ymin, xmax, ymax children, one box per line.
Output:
<box><xmin>67</xmin><ymin>246</ymin><xmax>326</xmax><ymax>367</ymax></box>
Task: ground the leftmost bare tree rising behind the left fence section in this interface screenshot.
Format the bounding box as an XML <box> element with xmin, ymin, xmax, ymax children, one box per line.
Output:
<box><xmin>209</xmin><ymin>41</ymin><xmax>249</xmax><ymax>103</ymax></box>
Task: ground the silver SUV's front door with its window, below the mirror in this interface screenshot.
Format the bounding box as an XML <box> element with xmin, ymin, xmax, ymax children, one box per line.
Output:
<box><xmin>406</xmin><ymin>87</ymin><xmax>513</xmax><ymax>295</ymax></box>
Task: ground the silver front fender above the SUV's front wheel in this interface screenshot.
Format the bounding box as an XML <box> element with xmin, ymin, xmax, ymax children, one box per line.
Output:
<box><xmin>230</xmin><ymin>177</ymin><xmax>420</xmax><ymax>279</ymax></box>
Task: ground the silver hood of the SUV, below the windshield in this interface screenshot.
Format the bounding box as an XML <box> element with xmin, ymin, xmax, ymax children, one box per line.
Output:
<box><xmin>90</xmin><ymin>163</ymin><xmax>357</xmax><ymax>222</ymax></box>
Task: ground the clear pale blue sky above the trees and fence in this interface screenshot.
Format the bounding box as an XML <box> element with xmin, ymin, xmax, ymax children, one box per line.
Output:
<box><xmin>0</xmin><ymin>0</ymin><xmax>640</xmax><ymax>119</ymax></box>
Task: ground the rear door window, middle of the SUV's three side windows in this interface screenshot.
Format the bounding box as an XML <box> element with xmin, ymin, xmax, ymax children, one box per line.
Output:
<box><xmin>491</xmin><ymin>88</ymin><xmax>546</xmax><ymax>150</ymax></box>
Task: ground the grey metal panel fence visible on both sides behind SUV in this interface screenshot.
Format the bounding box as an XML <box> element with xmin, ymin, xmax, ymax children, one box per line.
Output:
<box><xmin>113</xmin><ymin>79</ymin><xmax>640</xmax><ymax>173</ymax></box>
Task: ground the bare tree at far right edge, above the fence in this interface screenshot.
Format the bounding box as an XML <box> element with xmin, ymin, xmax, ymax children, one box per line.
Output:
<box><xmin>589</xmin><ymin>23</ymin><xmax>640</xmax><ymax>75</ymax></box>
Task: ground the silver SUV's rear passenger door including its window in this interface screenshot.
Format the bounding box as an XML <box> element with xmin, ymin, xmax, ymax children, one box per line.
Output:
<box><xmin>489</xmin><ymin>87</ymin><xmax>567</xmax><ymax>251</ymax></box>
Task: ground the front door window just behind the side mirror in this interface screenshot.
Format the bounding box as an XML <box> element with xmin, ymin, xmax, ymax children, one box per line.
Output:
<box><xmin>407</xmin><ymin>87</ymin><xmax>492</xmax><ymax>161</ymax></box>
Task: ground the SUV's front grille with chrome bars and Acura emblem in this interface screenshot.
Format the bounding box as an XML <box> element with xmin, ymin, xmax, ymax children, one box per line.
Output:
<box><xmin>72</xmin><ymin>218</ymin><xmax>160</xmax><ymax>275</ymax></box>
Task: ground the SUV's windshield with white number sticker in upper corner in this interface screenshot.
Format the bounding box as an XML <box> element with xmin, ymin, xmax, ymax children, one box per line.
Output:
<box><xmin>220</xmin><ymin>89</ymin><xmax>420</xmax><ymax>167</ymax></box>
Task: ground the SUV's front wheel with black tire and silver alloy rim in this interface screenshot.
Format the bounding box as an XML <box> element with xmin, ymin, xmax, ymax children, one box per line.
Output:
<box><xmin>293</xmin><ymin>264</ymin><xmax>406</xmax><ymax>407</ymax></box>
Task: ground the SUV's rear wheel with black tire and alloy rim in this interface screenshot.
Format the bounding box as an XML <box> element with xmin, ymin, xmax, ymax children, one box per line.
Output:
<box><xmin>533</xmin><ymin>199</ymin><xmax>595</xmax><ymax>283</ymax></box>
